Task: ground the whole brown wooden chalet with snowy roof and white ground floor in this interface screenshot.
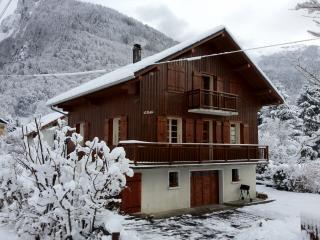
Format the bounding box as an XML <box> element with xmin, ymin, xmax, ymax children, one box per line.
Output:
<box><xmin>47</xmin><ymin>26</ymin><xmax>283</xmax><ymax>213</ymax></box>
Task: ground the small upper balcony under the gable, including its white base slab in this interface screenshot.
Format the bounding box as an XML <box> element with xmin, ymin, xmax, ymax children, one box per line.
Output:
<box><xmin>187</xmin><ymin>89</ymin><xmax>239</xmax><ymax>116</ymax></box>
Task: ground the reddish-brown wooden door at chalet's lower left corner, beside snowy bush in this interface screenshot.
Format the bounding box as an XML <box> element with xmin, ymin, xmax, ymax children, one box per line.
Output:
<box><xmin>121</xmin><ymin>173</ymin><xmax>141</xmax><ymax>213</ymax></box>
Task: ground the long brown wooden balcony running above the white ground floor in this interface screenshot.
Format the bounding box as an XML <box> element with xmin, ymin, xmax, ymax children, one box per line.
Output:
<box><xmin>119</xmin><ymin>141</ymin><xmax>268</xmax><ymax>165</ymax></box>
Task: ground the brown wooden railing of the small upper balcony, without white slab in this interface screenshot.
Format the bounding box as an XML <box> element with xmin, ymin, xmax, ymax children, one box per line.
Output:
<box><xmin>187</xmin><ymin>89</ymin><xmax>239</xmax><ymax>112</ymax></box>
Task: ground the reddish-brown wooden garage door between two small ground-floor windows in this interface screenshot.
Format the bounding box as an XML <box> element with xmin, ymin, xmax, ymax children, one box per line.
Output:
<box><xmin>190</xmin><ymin>171</ymin><xmax>219</xmax><ymax>207</ymax></box>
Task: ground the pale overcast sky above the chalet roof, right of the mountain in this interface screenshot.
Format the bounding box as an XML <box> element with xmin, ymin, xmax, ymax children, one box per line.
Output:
<box><xmin>85</xmin><ymin>0</ymin><xmax>320</xmax><ymax>54</ymax></box>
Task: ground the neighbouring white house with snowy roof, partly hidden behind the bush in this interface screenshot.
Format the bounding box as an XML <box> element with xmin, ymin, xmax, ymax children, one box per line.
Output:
<box><xmin>23</xmin><ymin>112</ymin><xmax>67</xmax><ymax>146</ymax></box>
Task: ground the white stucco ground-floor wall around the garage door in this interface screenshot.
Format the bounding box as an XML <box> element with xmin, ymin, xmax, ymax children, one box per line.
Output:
<box><xmin>135</xmin><ymin>164</ymin><xmax>256</xmax><ymax>213</ymax></box>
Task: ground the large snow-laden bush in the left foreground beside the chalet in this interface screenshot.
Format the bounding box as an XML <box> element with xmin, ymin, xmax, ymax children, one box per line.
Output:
<box><xmin>0</xmin><ymin>121</ymin><xmax>133</xmax><ymax>239</ymax></box>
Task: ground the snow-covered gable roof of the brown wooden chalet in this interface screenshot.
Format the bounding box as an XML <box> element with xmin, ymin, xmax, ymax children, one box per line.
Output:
<box><xmin>47</xmin><ymin>26</ymin><xmax>283</xmax><ymax>106</ymax></box>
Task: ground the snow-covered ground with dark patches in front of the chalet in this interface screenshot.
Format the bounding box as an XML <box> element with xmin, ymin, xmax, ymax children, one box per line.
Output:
<box><xmin>125</xmin><ymin>186</ymin><xmax>320</xmax><ymax>240</ymax></box>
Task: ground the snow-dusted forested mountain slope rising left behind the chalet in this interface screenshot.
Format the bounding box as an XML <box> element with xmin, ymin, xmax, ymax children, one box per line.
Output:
<box><xmin>0</xmin><ymin>0</ymin><xmax>176</xmax><ymax>117</ymax></box>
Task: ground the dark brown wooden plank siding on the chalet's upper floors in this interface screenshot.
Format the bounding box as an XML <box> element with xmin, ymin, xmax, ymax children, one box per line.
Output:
<box><xmin>61</xmin><ymin>36</ymin><xmax>261</xmax><ymax>144</ymax></box>
